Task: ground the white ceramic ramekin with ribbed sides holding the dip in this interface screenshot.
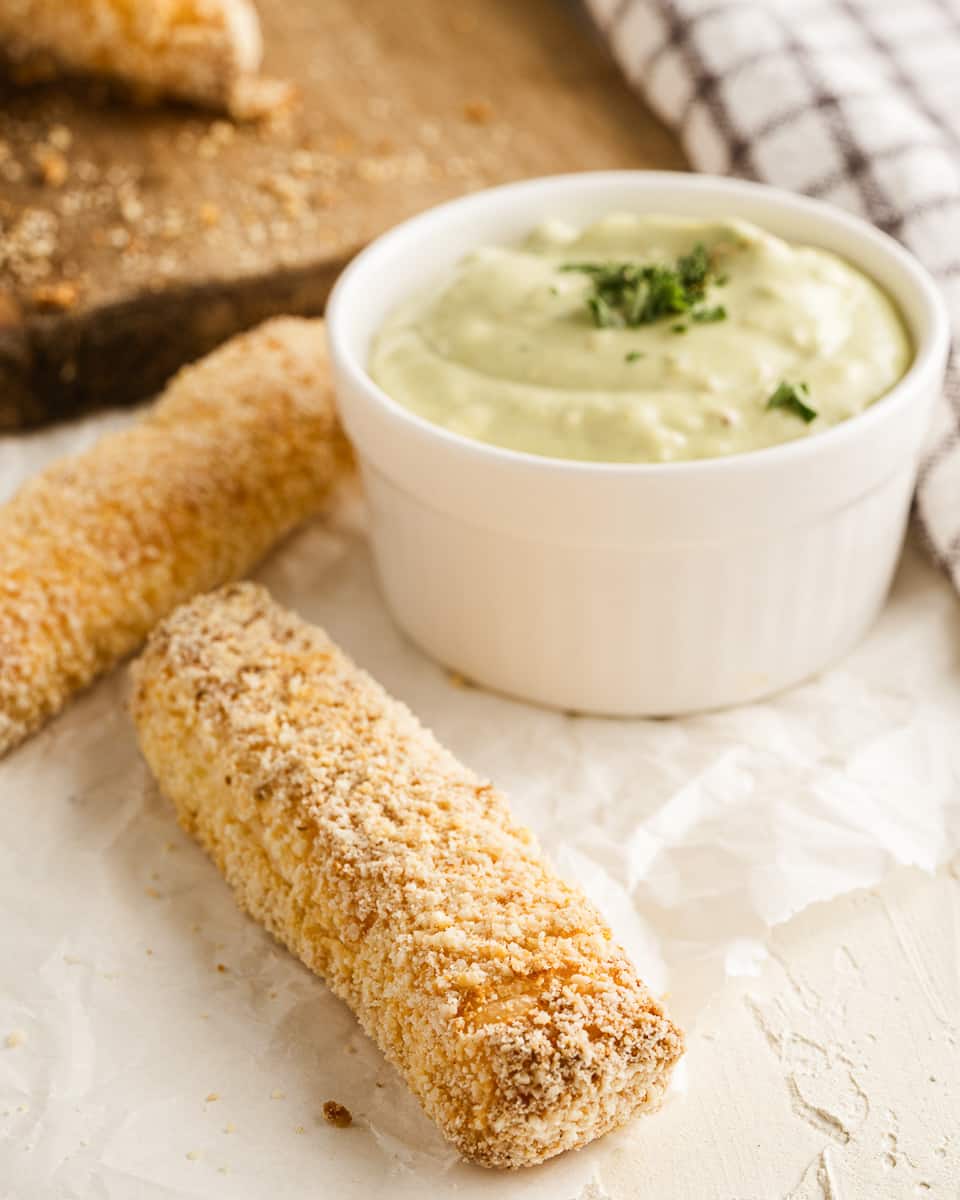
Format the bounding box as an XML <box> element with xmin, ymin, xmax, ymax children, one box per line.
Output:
<box><xmin>328</xmin><ymin>172</ymin><xmax>948</xmax><ymax>715</ymax></box>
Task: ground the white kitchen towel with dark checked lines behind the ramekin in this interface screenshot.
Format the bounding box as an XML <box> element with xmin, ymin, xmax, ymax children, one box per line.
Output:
<box><xmin>587</xmin><ymin>0</ymin><xmax>960</xmax><ymax>588</ymax></box>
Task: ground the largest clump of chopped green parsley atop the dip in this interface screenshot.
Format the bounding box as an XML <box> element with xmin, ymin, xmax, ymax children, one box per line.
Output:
<box><xmin>560</xmin><ymin>241</ymin><xmax>726</xmax><ymax>331</ymax></box>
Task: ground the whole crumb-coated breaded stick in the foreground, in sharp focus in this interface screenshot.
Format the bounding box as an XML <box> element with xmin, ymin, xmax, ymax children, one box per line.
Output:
<box><xmin>133</xmin><ymin>583</ymin><xmax>683</xmax><ymax>1166</ymax></box>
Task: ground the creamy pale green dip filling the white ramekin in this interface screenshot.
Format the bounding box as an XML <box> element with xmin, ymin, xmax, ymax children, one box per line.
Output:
<box><xmin>370</xmin><ymin>214</ymin><xmax>912</xmax><ymax>462</ymax></box>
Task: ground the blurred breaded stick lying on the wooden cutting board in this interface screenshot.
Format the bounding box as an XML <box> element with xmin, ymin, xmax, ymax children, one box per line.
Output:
<box><xmin>0</xmin><ymin>0</ymin><xmax>289</xmax><ymax>116</ymax></box>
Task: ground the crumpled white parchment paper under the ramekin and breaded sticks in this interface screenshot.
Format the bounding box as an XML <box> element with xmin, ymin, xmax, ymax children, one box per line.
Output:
<box><xmin>0</xmin><ymin>416</ymin><xmax>960</xmax><ymax>1200</ymax></box>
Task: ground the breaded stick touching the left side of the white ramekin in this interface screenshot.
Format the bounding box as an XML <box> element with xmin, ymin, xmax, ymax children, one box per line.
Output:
<box><xmin>0</xmin><ymin>318</ymin><xmax>348</xmax><ymax>755</ymax></box>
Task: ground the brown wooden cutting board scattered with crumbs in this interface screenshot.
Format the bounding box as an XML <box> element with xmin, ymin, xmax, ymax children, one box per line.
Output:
<box><xmin>0</xmin><ymin>0</ymin><xmax>683</xmax><ymax>428</ymax></box>
